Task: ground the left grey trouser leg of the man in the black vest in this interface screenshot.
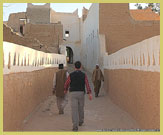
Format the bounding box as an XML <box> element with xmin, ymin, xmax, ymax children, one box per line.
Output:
<box><xmin>71</xmin><ymin>92</ymin><xmax>79</xmax><ymax>131</ymax></box>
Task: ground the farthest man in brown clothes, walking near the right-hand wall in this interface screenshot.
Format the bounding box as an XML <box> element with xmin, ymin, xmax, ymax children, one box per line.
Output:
<box><xmin>92</xmin><ymin>64</ymin><xmax>104</xmax><ymax>97</ymax></box>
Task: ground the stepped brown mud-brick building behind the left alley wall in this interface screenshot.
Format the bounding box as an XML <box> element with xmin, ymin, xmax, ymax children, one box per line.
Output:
<box><xmin>4</xmin><ymin>3</ymin><xmax>63</xmax><ymax>53</ymax></box>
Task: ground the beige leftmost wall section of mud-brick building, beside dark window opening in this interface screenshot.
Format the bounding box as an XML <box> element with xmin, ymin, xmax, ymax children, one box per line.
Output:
<box><xmin>7</xmin><ymin>12</ymin><xmax>26</xmax><ymax>32</ymax></box>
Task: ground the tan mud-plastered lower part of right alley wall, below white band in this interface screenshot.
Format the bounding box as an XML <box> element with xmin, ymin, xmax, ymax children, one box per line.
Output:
<box><xmin>104</xmin><ymin>69</ymin><xmax>160</xmax><ymax>129</ymax></box>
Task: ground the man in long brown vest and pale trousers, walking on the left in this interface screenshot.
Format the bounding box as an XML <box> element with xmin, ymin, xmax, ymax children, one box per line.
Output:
<box><xmin>53</xmin><ymin>64</ymin><xmax>69</xmax><ymax>114</ymax></box>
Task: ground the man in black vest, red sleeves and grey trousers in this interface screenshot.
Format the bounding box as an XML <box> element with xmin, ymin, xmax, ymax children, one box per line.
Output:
<box><xmin>64</xmin><ymin>61</ymin><xmax>92</xmax><ymax>131</ymax></box>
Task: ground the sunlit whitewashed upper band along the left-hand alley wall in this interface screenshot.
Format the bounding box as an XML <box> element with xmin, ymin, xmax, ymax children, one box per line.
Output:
<box><xmin>3</xmin><ymin>42</ymin><xmax>67</xmax><ymax>74</ymax></box>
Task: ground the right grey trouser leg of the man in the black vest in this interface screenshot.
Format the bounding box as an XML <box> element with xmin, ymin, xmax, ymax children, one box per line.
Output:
<box><xmin>78</xmin><ymin>92</ymin><xmax>84</xmax><ymax>126</ymax></box>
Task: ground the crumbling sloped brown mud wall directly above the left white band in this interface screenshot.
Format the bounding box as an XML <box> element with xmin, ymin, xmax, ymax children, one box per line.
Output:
<box><xmin>3</xmin><ymin>24</ymin><xmax>46</xmax><ymax>52</ymax></box>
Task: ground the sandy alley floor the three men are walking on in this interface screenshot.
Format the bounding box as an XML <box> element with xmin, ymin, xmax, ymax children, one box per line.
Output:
<box><xmin>23</xmin><ymin>65</ymin><xmax>139</xmax><ymax>131</ymax></box>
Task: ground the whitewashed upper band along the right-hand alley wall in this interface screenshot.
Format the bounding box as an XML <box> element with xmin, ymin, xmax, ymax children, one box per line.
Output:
<box><xmin>104</xmin><ymin>36</ymin><xmax>160</xmax><ymax>72</ymax></box>
